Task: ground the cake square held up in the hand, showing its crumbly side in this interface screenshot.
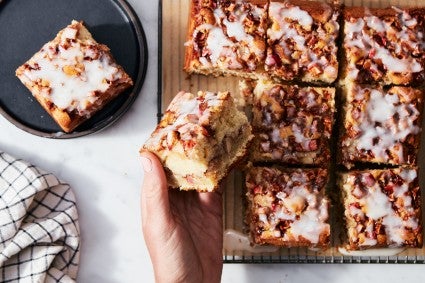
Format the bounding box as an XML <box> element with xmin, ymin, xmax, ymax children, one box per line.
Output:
<box><xmin>142</xmin><ymin>91</ymin><xmax>253</xmax><ymax>192</ymax></box>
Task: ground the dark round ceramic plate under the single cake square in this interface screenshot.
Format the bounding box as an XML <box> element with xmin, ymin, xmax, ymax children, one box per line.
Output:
<box><xmin>0</xmin><ymin>0</ymin><xmax>147</xmax><ymax>138</ymax></box>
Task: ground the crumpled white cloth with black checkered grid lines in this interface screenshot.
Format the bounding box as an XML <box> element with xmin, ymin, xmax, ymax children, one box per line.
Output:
<box><xmin>0</xmin><ymin>151</ymin><xmax>80</xmax><ymax>282</ymax></box>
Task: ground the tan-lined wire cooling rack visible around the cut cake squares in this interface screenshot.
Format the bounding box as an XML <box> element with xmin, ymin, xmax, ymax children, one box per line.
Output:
<box><xmin>158</xmin><ymin>0</ymin><xmax>425</xmax><ymax>264</ymax></box>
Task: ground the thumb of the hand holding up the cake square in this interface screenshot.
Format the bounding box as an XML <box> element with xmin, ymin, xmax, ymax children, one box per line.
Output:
<box><xmin>140</xmin><ymin>151</ymin><xmax>171</xmax><ymax>231</ymax></box>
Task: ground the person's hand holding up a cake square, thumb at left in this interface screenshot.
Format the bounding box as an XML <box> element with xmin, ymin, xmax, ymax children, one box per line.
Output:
<box><xmin>141</xmin><ymin>152</ymin><xmax>223</xmax><ymax>283</ymax></box>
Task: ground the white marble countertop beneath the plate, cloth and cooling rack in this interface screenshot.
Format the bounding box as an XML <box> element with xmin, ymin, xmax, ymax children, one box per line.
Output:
<box><xmin>0</xmin><ymin>0</ymin><xmax>425</xmax><ymax>283</ymax></box>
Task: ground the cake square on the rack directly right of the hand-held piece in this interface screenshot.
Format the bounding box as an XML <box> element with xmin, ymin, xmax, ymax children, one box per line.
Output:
<box><xmin>248</xmin><ymin>79</ymin><xmax>335</xmax><ymax>167</ymax></box>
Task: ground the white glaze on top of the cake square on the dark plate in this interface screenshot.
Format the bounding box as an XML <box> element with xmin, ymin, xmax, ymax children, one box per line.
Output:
<box><xmin>24</xmin><ymin>27</ymin><xmax>122</xmax><ymax>115</ymax></box>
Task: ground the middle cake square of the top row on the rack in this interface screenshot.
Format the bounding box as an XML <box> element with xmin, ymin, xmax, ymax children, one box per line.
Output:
<box><xmin>265</xmin><ymin>0</ymin><xmax>340</xmax><ymax>84</ymax></box>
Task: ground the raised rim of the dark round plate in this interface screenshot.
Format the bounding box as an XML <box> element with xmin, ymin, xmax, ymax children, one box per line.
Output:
<box><xmin>0</xmin><ymin>0</ymin><xmax>149</xmax><ymax>139</ymax></box>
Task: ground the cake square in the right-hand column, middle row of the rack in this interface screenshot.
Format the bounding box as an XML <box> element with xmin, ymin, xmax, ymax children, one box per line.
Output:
<box><xmin>339</xmin><ymin>84</ymin><xmax>423</xmax><ymax>168</ymax></box>
